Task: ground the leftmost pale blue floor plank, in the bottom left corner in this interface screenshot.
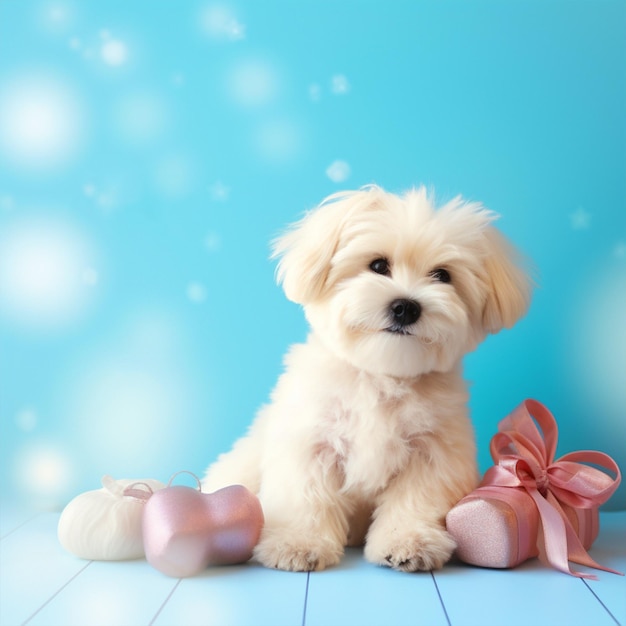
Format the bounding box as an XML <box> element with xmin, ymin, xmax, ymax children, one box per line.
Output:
<box><xmin>0</xmin><ymin>513</ymin><xmax>89</xmax><ymax>626</ymax></box>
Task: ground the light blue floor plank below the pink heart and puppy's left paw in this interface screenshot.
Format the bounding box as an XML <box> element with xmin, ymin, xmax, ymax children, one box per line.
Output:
<box><xmin>153</xmin><ymin>563</ymin><xmax>308</xmax><ymax>626</ymax></box>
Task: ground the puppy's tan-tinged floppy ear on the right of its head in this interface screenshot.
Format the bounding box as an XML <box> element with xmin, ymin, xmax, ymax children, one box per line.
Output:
<box><xmin>483</xmin><ymin>226</ymin><xmax>532</xmax><ymax>333</ymax></box>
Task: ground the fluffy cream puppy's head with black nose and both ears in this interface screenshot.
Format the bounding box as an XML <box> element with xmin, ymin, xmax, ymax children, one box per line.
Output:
<box><xmin>274</xmin><ymin>187</ymin><xmax>531</xmax><ymax>377</ymax></box>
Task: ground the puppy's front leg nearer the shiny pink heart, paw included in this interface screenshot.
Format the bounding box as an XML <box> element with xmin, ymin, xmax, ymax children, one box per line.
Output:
<box><xmin>254</xmin><ymin>446</ymin><xmax>348</xmax><ymax>571</ymax></box>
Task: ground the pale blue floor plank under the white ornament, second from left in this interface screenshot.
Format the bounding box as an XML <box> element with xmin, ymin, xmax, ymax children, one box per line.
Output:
<box><xmin>28</xmin><ymin>559</ymin><xmax>178</xmax><ymax>626</ymax></box>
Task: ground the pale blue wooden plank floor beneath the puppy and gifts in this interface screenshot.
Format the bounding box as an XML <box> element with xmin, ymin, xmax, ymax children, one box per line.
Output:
<box><xmin>0</xmin><ymin>506</ymin><xmax>626</xmax><ymax>626</ymax></box>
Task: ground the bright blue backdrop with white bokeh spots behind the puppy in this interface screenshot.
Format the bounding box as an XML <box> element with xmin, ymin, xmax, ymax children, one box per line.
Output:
<box><xmin>0</xmin><ymin>0</ymin><xmax>626</xmax><ymax>508</ymax></box>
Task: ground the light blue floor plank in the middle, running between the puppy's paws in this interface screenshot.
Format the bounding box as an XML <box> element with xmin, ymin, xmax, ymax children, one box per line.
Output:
<box><xmin>305</xmin><ymin>548</ymin><xmax>447</xmax><ymax>626</ymax></box>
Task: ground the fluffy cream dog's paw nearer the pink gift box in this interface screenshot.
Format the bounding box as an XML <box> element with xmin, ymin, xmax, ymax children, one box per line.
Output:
<box><xmin>365</xmin><ymin>528</ymin><xmax>456</xmax><ymax>572</ymax></box>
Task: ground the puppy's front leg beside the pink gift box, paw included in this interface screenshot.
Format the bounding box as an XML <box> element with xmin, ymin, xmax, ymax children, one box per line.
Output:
<box><xmin>365</xmin><ymin>438</ymin><xmax>475</xmax><ymax>572</ymax></box>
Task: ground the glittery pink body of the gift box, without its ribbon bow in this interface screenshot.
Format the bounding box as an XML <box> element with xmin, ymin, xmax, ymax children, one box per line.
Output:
<box><xmin>446</xmin><ymin>486</ymin><xmax>599</xmax><ymax>568</ymax></box>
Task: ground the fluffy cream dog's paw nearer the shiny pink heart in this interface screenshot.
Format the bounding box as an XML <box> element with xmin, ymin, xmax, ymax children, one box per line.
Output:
<box><xmin>254</xmin><ymin>530</ymin><xmax>343</xmax><ymax>572</ymax></box>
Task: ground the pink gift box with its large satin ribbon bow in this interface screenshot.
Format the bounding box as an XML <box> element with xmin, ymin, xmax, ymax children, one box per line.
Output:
<box><xmin>446</xmin><ymin>400</ymin><xmax>621</xmax><ymax>577</ymax></box>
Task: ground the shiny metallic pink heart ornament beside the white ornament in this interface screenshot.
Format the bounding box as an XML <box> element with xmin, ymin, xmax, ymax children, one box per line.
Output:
<box><xmin>142</xmin><ymin>485</ymin><xmax>264</xmax><ymax>578</ymax></box>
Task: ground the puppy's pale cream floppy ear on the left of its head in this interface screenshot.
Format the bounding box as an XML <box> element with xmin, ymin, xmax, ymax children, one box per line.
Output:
<box><xmin>272</xmin><ymin>198</ymin><xmax>345</xmax><ymax>304</ymax></box>
